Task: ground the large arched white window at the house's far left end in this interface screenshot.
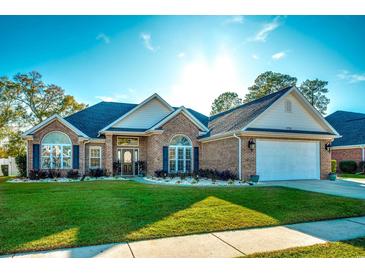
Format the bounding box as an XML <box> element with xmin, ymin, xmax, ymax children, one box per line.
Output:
<box><xmin>41</xmin><ymin>131</ymin><xmax>72</xmax><ymax>169</ymax></box>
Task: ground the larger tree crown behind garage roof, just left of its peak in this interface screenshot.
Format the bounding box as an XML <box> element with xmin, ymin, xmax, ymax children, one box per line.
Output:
<box><xmin>244</xmin><ymin>71</ymin><xmax>297</xmax><ymax>103</ymax></box>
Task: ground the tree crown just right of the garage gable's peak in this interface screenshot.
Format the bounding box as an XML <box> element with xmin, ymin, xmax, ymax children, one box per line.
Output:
<box><xmin>299</xmin><ymin>79</ymin><xmax>330</xmax><ymax>115</ymax></box>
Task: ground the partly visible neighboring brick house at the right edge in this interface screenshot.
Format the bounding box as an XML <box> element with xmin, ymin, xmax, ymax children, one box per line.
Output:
<box><xmin>326</xmin><ymin>111</ymin><xmax>365</xmax><ymax>167</ymax></box>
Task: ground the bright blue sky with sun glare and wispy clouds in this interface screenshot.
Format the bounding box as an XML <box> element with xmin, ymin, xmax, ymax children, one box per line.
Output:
<box><xmin>0</xmin><ymin>16</ymin><xmax>365</xmax><ymax>114</ymax></box>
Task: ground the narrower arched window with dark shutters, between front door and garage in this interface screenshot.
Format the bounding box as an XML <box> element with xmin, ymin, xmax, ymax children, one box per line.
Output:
<box><xmin>169</xmin><ymin>135</ymin><xmax>192</xmax><ymax>173</ymax></box>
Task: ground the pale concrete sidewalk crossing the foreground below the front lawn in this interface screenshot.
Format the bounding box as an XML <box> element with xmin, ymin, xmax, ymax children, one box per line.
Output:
<box><xmin>2</xmin><ymin>216</ymin><xmax>365</xmax><ymax>258</ymax></box>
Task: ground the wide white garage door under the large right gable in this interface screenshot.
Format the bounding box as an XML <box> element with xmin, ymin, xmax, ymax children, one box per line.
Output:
<box><xmin>256</xmin><ymin>140</ymin><xmax>320</xmax><ymax>181</ymax></box>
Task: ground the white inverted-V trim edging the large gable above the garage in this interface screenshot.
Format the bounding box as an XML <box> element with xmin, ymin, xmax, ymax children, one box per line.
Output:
<box><xmin>242</xmin><ymin>86</ymin><xmax>340</xmax><ymax>138</ymax></box>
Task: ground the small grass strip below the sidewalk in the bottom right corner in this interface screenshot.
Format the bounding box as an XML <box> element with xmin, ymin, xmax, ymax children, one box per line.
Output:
<box><xmin>247</xmin><ymin>238</ymin><xmax>365</xmax><ymax>258</ymax></box>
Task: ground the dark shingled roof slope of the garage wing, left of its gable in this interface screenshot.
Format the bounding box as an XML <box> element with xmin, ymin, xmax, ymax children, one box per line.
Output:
<box><xmin>201</xmin><ymin>86</ymin><xmax>292</xmax><ymax>138</ymax></box>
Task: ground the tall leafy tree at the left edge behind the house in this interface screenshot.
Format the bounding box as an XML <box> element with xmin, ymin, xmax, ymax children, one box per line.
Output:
<box><xmin>0</xmin><ymin>71</ymin><xmax>86</xmax><ymax>156</ymax></box>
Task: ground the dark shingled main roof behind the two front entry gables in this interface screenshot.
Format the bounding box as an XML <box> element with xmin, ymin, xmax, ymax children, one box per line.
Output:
<box><xmin>65</xmin><ymin>102</ymin><xmax>209</xmax><ymax>138</ymax></box>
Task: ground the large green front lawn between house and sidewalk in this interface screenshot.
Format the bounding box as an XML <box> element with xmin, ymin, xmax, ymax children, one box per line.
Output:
<box><xmin>0</xmin><ymin>181</ymin><xmax>365</xmax><ymax>254</ymax></box>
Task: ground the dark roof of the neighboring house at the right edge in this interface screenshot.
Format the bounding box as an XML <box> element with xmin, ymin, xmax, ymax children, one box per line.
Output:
<box><xmin>326</xmin><ymin>110</ymin><xmax>365</xmax><ymax>146</ymax></box>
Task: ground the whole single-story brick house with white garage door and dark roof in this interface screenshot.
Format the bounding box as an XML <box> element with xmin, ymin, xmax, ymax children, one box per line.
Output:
<box><xmin>23</xmin><ymin>87</ymin><xmax>339</xmax><ymax>180</ymax></box>
